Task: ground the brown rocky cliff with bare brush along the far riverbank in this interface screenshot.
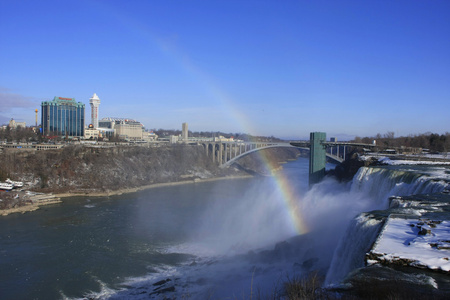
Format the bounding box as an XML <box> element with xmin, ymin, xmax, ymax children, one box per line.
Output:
<box><xmin>0</xmin><ymin>145</ymin><xmax>298</xmax><ymax>193</ymax></box>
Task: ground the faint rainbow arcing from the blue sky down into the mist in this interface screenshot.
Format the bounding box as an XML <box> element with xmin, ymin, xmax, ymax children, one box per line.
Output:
<box><xmin>97</xmin><ymin>2</ymin><xmax>308</xmax><ymax>234</ymax></box>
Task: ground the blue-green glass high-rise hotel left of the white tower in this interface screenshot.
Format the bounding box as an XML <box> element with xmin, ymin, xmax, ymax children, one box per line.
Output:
<box><xmin>41</xmin><ymin>97</ymin><xmax>85</xmax><ymax>136</ymax></box>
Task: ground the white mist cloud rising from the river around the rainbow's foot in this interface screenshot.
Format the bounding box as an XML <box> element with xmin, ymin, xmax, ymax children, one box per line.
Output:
<box><xmin>139</xmin><ymin>159</ymin><xmax>385</xmax><ymax>297</ymax></box>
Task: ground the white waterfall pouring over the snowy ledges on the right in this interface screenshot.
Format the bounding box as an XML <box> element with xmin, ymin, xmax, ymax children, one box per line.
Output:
<box><xmin>325</xmin><ymin>166</ymin><xmax>450</xmax><ymax>286</ymax></box>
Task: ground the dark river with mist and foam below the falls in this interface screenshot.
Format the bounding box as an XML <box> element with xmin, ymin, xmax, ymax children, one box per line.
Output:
<box><xmin>0</xmin><ymin>158</ymin><xmax>443</xmax><ymax>299</ymax></box>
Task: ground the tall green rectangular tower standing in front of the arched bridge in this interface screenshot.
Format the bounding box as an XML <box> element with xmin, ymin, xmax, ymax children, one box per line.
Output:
<box><xmin>309</xmin><ymin>132</ymin><xmax>327</xmax><ymax>186</ymax></box>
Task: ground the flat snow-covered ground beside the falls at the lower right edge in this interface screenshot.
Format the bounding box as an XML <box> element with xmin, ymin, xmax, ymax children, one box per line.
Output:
<box><xmin>367</xmin><ymin>218</ymin><xmax>450</xmax><ymax>272</ymax></box>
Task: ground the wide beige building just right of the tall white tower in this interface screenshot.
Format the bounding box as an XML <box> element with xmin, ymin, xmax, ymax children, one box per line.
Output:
<box><xmin>98</xmin><ymin>118</ymin><xmax>144</xmax><ymax>140</ymax></box>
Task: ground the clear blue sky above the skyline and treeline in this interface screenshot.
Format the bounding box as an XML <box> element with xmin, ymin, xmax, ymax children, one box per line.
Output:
<box><xmin>0</xmin><ymin>0</ymin><xmax>450</xmax><ymax>138</ymax></box>
